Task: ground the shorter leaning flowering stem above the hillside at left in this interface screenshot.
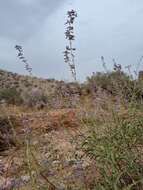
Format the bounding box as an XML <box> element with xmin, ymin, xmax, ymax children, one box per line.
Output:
<box><xmin>15</xmin><ymin>45</ymin><xmax>32</xmax><ymax>75</ymax></box>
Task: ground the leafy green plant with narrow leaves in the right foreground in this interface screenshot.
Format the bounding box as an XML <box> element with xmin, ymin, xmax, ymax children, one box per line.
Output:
<box><xmin>83</xmin><ymin>110</ymin><xmax>143</xmax><ymax>190</ymax></box>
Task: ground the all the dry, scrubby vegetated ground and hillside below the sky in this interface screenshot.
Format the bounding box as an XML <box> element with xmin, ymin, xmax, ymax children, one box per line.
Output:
<box><xmin>0</xmin><ymin>66</ymin><xmax>143</xmax><ymax>190</ymax></box>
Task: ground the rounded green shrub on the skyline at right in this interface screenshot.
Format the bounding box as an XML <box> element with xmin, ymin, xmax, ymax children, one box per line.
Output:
<box><xmin>86</xmin><ymin>71</ymin><xmax>143</xmax><ymax>102</ymax></box>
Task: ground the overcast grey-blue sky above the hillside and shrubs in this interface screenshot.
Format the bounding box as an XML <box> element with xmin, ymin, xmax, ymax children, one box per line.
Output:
<box><xmin>0</xmin><ymin>0</ymin><xmax>143</xmax><ymax>80</ymax></box>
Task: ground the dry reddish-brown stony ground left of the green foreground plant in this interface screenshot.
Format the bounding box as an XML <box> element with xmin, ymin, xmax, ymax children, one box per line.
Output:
<box><xmin>0</xmin><ymin>109</ymin><xmax>95</xmax><ymax>190</ymax></box>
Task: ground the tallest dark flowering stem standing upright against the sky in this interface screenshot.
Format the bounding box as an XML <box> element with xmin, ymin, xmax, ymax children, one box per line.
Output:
<box><xmin>64</xmin><ymin>10</ymin><xmax>77</xmax><ymax>81</ymax></box>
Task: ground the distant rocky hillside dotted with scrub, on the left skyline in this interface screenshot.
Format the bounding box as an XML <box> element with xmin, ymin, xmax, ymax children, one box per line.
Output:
<box><xmin>0</xmin><ymin>70</ymin><xmax>80</xmax><ymax>106</ymax></box>
